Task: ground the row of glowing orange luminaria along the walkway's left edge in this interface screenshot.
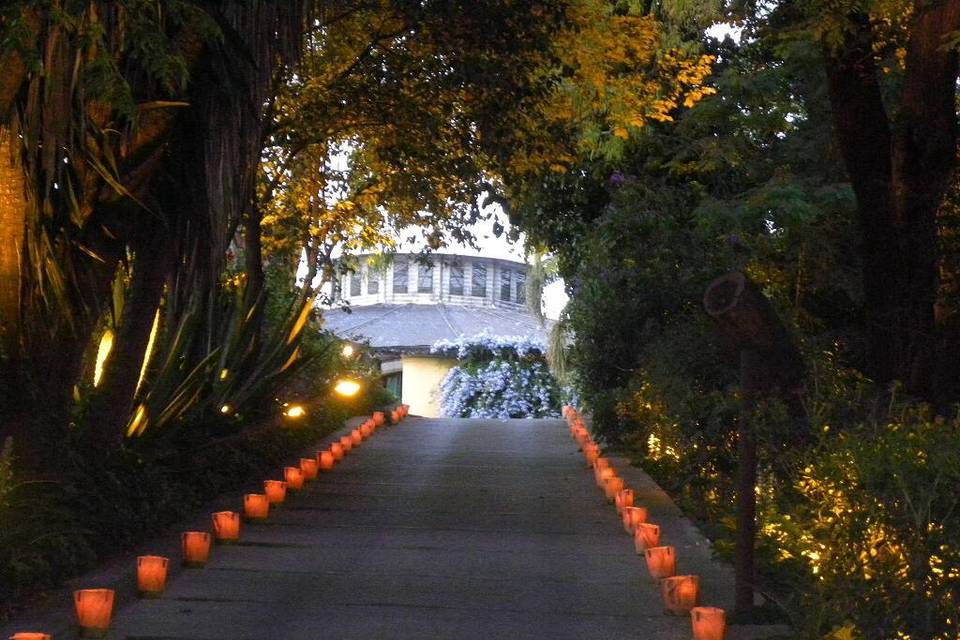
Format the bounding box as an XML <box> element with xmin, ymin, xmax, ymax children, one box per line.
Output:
<box><xmin>10</xmin><ymin>404</ymin><xmax>410</xmax><ymax>640</ymax></box>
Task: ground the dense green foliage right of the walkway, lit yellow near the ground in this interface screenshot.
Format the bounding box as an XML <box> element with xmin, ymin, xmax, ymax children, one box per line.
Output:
<box><xmin>512</xmin><ymin>3</ymin><xmax>960</xmax><ymax>640</ymax></box>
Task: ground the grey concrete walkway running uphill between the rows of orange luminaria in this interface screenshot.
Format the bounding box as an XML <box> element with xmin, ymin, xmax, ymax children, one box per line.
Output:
<box><xmin>5</xmin><ymin>418</ymin><xmax>788</xmax><ymax>640</ymax></box>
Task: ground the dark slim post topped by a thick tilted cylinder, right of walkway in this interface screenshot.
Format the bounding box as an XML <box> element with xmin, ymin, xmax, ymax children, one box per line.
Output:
<box><xmin>703</xmin><ymin>273</ymin><xmax>803</xmax><ymax>617</ymax></box>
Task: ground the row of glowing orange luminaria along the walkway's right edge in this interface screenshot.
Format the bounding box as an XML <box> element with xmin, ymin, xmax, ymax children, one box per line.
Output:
<box><xmin>563</xmin><ymin>406</ymin><xmax>726</xmax><ymax>640</ymax></box>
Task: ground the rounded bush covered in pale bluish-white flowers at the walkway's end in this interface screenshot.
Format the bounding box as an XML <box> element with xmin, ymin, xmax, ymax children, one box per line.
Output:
<box><xmin>431</xmin><ymin>333</ymin><xmax>563</xmax><ymax>419</ymax></box>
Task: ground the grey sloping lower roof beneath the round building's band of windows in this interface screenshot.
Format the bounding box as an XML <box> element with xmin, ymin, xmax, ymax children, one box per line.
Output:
<box><xmin>323</xmin><ymin>304</ymin><xmax>551</xmax><ymax>353</ymax></box>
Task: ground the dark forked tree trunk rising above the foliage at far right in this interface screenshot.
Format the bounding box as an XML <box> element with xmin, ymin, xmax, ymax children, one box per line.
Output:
<box><xmin>825</xmin><ymin>0</ymin><xmax>960</xmax><ymax>400</ymax></box>
